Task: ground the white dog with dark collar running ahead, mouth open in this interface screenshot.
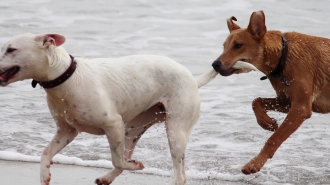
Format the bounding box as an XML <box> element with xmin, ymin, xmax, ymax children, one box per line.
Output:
<box><xmin>0</xmin><ymin>34</ymin><xmax>217</xmax><ymax>185</ymax></box>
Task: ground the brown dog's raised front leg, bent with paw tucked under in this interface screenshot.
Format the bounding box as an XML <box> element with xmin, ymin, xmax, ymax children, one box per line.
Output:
<box><xmin>252</xmin><ymin>97</ymin><xmax>290</xmax><ymax>131</ymax></box>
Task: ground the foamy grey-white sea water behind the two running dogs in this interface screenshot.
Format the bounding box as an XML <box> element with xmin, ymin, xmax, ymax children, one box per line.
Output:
<box><xmin>0</xmin><ymin>0</ymin><xmax>330</xmax><ymax>185</ymax></box>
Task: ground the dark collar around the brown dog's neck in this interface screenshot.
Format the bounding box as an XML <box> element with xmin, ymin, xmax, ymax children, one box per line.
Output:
<box><xmin>260</xmin><ymin>34</ymin><xmax>290</xmax><ymax>86</ymax></box>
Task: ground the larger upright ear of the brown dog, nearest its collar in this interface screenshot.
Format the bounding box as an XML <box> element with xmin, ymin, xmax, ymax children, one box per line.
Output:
<box><xmin>248</xmin><ymin>10</ymin><xmax>267</xmax><ymax>39</ymax></box>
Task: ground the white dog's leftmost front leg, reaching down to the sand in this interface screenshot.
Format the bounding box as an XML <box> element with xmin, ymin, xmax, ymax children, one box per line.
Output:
<box><xmin>40</xmin><ymin>123</ymin><xmax>78</xmax><ymax>185</ymax></box>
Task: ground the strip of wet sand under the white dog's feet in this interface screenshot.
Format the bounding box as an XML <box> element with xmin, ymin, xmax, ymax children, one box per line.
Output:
<box><xmin>0</xmin><ymin>160</ymin><xmax>244</xmax><ymax>185</ymax></box>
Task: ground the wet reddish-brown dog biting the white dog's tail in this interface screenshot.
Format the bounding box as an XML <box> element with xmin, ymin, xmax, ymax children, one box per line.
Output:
<box><xmin>213</xmin><ymin>11</ymin><xmax>330</xmax><ymax>174</ymax></box>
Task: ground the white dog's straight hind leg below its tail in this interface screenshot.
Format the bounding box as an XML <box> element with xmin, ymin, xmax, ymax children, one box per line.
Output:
<box><xmin>165</xmin><ymin>90</ymin><xmax>200</xmax><ymax>185</ymax></box>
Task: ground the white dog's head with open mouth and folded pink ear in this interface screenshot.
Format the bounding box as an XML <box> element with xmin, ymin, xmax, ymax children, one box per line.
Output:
<box><xmin>0</xmin><ymin>34</ymin><xmax>65</xmax><ymax>86</ymax></box>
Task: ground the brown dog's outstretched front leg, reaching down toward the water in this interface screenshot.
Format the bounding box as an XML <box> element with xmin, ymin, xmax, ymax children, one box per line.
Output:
<box><xmin>242</xmin><ymin>101</ymin><xmax>312</xmax><ymax>174</ymax></box>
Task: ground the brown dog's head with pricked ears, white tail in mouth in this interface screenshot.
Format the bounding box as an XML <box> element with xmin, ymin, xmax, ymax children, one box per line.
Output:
<box><xmin>212</xmin><ymin>11</ymin><xmax>267</xmax><ymax>76</ymax></box>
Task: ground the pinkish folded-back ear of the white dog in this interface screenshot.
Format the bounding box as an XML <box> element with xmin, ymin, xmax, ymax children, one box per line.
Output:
<box><xmin>35</xmin><ymin>34</ymin><xmax>65</xmax><ymax>48</ymax></box>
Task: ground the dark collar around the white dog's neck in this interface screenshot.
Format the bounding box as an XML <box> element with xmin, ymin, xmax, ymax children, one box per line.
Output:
<box><xmin>31</xmin><ymin>55</ymin><xmax>77</xmax><ymax>89</ymax></box>
